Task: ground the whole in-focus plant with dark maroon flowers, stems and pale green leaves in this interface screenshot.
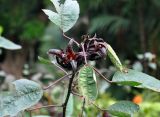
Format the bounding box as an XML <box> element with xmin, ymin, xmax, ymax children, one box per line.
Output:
<box><xmin>0</xmin><ymin>0</ymin><xmax>160</xmax><ymax>117</ymax></box>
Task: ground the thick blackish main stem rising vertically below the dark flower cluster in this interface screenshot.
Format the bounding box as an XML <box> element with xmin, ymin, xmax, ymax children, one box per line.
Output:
<box><xmin>63</xmin><ymin>71</ymin><xmax>75</xmax><ymax>117</ymax></box>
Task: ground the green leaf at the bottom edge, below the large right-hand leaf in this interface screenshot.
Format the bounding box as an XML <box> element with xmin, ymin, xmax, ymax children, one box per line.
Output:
<box><xmin>108</xmin><ymin>101</ymin><xmax>139</xmax><ymax>117</ymax></box>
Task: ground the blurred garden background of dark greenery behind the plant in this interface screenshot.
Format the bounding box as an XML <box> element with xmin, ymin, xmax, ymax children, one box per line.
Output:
<box><xmin>0</xmin><ymin>0</ymin><xmax>160</xmax><ymax>117</ymax></box>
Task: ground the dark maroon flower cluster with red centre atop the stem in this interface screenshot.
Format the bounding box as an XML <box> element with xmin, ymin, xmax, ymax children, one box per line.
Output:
<box><xmin>48</xmin><ymin>36</ymin><xmax>107</xmax><ymax>70</ymax></box>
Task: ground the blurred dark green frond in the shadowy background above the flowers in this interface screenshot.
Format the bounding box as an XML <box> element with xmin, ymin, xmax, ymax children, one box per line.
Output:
<box><xmin>89</xmin><ymin>14</ymin><xmax>130</xmax><ymax>34</ymax></box>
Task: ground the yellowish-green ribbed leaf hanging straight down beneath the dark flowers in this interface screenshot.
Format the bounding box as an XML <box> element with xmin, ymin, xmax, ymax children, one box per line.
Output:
<box><xmin>78</xmin><ymin>65</ymin><xmax>98</xmax><ymax>101</ymax></box>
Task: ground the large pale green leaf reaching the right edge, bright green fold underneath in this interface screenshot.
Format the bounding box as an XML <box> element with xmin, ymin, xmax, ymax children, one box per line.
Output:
<box><xmin>112</xmin><ymin>69</ymin><xmax>160</xmax><ymax>92</ymax></box>
